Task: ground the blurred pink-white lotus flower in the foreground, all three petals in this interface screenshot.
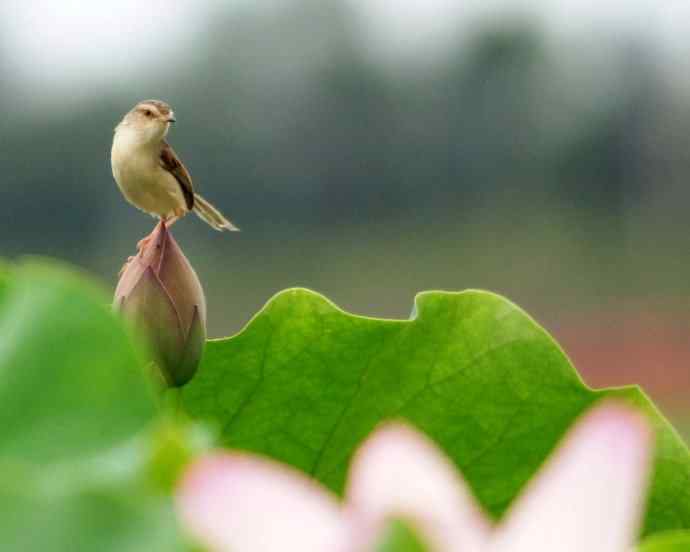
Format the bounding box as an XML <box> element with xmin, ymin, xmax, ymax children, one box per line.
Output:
<box><xmin>177</xmin><ymin>403</ymin><xmax>652</xmax><ymax>552</ymax></box>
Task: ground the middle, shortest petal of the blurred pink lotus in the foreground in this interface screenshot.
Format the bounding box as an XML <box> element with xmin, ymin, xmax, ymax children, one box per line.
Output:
<box><xmin>346</xmin><ymin>424</ymin><xmax>490</xmax><ymax>551</ymax></box>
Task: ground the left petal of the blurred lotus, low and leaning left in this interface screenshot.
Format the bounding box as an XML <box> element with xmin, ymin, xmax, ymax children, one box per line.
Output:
<box><xmin>177</xmin><ymin>453</ymin><xmax>349</xmax><ymax>552</ymax></box>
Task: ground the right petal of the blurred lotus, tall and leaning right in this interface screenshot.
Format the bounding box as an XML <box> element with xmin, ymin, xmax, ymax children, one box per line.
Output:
<box><xmin>489</xmin><ymin>403</ymin><xmax>652</xmax><ymax>552</ymax></box>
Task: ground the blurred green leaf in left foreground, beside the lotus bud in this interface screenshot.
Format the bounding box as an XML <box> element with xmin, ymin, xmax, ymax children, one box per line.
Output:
<box><xmin>0</xmin><ymin>262</ymin><xmax>183</xmax><ymax>552</ymax></box>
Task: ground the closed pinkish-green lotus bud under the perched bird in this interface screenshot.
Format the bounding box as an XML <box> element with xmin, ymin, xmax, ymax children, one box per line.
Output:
<box><xmin>115</xmin><ymin>222</ymin><xmax>206</xmax><ymax>387</ymax></box>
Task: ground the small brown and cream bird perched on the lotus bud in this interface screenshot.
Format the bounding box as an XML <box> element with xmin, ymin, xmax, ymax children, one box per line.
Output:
<box><xmin>110</xmin><ymin>100</ymin><xmax>239</xmax><ymax>243</ymax></box>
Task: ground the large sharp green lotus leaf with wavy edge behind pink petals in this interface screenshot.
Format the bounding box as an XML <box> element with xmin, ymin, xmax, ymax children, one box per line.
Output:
<box><xmin>182</xmin><ymin>289</ymin><xmax>690</xmax><ymax>534</ymax></box>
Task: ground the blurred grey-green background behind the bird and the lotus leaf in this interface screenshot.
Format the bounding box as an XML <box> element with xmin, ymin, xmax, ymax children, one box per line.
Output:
<box><xmin>0</xmin><ymin>0</ymin><xmax>690</xmax><ymax>429</ymax></box>
